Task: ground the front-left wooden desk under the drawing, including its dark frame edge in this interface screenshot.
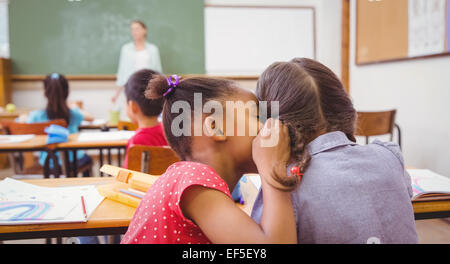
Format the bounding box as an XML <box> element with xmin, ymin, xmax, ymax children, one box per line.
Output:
<box><xmin>0</xmin><ymin>177</ymin><xmax>136</xmax><ymax>240</ymax></box>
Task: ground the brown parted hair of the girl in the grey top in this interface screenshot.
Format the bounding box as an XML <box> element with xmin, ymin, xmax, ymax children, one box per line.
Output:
<box><xmin>256</xmin><ymin>58</ymin><xmax>356</xmax><ymax>188</ymax></box>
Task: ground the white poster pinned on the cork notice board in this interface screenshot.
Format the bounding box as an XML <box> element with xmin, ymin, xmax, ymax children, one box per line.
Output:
<box><xmin>408</xmin><ymin>0</ymin><xmax>448</xmax><ymax>57</ymax></box>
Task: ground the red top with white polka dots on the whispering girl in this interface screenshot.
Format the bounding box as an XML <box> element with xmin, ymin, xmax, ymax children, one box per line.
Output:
<box><xmin>121</xmin><ymin>161</ymin><xmax>231</xmax><ymax>244</ymax></box>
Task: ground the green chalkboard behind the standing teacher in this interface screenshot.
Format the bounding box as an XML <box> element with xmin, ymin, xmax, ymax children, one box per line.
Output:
<box><xmin>9</xmin><ymin>0</ymin><xmax>205</xmax><ymax>75</ymax></box>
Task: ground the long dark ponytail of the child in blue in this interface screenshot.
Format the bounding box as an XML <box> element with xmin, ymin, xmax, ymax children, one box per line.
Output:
<box><xmin>44</xmin><ymin>73</ymin><xmax>70</xmax><ymax>124</ymax></box>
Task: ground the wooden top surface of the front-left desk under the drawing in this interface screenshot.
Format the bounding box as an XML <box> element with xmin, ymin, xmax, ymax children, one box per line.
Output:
<box><xmin>0</xmin><ymin>177</ymin><xmax>136</xmax><ymax>234</ymax></box>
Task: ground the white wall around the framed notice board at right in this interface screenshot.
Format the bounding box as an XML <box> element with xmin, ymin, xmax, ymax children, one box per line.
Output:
<box><xmin>350</xmin><ymin>0</ymin><xmax>450</xmax><ymax>177</ymax></box>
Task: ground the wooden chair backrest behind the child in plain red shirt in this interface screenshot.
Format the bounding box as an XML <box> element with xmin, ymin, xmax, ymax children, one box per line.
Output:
<box><xmin>128</xmin><ymin>145</ymin><xmax>180</xmax><ymax>175</ymax></box>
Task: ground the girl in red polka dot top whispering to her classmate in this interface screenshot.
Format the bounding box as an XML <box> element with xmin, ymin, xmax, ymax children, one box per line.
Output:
<box><xmin>121</xmin><ymin>75</ymin><xmax>298</xmax><ymax>244</ymax></box>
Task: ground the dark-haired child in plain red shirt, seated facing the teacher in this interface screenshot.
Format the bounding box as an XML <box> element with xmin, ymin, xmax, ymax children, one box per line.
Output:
<box><xmin>123</xmin><ymin>70</ymin><xmax>168</xmax><ymax>168</ymax></box>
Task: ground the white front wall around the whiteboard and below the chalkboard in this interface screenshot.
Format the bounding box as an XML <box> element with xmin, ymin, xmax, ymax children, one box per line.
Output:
<box><xmin>13</xmin><ymin>0</ymin><xmax>341</xmax><ymax>121</ymax></box>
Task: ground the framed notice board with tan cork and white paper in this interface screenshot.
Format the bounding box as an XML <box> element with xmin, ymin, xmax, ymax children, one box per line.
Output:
<box><xmin>356</xmin><ymin>0</ymin><xmax>450</xmax><ymax>65</ymax></box>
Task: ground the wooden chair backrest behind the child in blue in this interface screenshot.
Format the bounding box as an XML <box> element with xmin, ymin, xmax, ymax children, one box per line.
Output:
<box><xmin>2</xmin><ymin>119</ymin><xmax>67</xmax><ymax>135</ymax></box>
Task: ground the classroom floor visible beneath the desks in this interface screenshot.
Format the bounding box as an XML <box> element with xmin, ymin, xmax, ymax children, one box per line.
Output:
<box><xmin>0</xmin><ymin>166</ymin><xmax>450</xmax><ymax>244</ymax></box>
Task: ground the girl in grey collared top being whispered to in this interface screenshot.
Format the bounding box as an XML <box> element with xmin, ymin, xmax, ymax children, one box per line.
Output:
<box><xmin>252</xmin><ymin>58</ymin><xmax>417</xmax><ymax>244</ymax></box>
